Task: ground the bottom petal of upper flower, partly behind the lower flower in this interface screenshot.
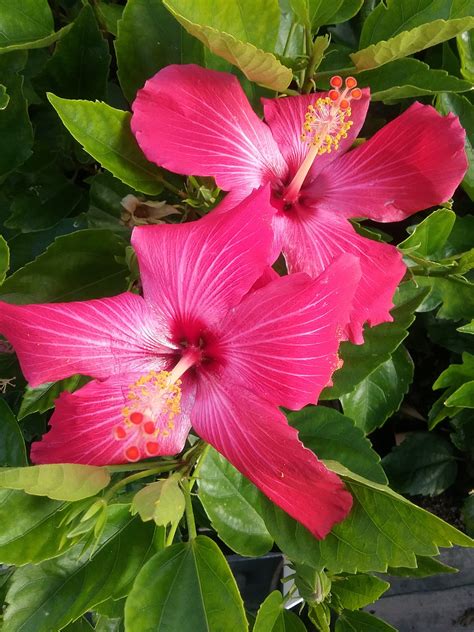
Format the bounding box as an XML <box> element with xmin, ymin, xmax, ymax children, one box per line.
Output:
<box><xmin>275</xmin><ymin>207</ymin><xmax>406</xmax><ymax>343</ymax></box>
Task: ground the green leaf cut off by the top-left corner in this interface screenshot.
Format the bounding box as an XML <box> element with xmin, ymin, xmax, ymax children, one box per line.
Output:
<box><xmin>0</xmin><ymin>0</ymin><xmax>54</xmax><ymax>49</ymax></box>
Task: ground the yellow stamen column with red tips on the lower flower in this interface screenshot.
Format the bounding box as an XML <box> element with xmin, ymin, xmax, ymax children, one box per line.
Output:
<box><xmin>113</xmin><ymin>350</ymin><xmax>199</xmax><ymax>461</ymax></box>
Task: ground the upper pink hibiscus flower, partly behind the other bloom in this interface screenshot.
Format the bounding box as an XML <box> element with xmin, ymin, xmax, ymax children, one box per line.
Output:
<box><xmin>132</xmin><ymin>65</ymin><xmax>467</xmax><ymax>342</ymax></box>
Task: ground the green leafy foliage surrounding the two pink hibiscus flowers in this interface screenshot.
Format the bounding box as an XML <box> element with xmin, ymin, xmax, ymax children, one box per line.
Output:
<box><xmin>0</xmin><ymin>0</ymin><xmax>474</xmax><ymax>632</ymax></box>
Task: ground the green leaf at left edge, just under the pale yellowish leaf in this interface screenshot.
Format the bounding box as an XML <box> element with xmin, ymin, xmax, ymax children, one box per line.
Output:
<box><xmin>0</xmin><ymin>489</ymin><xmax>71</xmax><ymax>566</ymax></box>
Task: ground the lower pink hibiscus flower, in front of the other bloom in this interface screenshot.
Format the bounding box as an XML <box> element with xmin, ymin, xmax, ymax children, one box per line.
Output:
<box><xmin>0</xmin><ymin>187</ymin><xmax>360</xmax><ymax>538</ymax></box>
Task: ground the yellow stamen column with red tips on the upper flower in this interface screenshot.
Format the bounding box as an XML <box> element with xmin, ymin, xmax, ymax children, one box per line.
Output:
<box><xmin>284</xmin><ymin>75</ymin><xmax>362</xmax><ymax>205</ymax></box>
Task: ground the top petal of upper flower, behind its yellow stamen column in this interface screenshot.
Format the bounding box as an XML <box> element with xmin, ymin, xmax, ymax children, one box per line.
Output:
<box><xmin>262</xmin><ymin>89</ymin><xmax>370</xmax><ymax>179</ymax></box>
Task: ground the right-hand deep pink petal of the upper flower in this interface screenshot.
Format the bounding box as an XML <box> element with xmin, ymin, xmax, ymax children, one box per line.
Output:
<box><xmin>305</xmin><ymin>103</ymin><xmax>467</xmax><ymax>222</ymax></box>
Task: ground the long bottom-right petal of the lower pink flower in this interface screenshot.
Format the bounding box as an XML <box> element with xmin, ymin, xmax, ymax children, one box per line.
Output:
<box><xmin>191</xmin><ymin>378</ymin><xmax>352</xmax><ymax>538</ymax></box>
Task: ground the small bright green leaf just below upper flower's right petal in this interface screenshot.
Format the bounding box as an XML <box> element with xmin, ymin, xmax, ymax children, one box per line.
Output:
<box><xmin>398</xmin><ymin>208</ymin><xmax>456</xmax><ymax>257</ymax></box>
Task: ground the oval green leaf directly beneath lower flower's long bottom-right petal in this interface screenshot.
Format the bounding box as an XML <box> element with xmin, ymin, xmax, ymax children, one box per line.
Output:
<box><xmin>199</xmin><ymin>448</ymin><xmax>273</xmax><ymax>557</ymax></box>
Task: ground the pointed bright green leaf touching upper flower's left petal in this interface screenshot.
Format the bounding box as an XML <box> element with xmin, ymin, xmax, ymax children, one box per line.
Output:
<box><xmin>48</xmin><ymin>94</ymin><xmax>162</xmax><ymax>195</ymax></box>
